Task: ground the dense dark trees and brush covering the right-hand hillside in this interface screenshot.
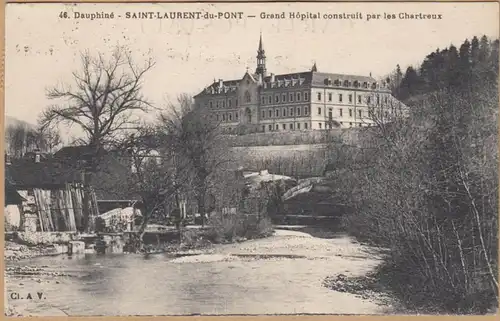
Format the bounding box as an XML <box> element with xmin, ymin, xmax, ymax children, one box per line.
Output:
<box><xmin>332</xmin><ymin>37</ymin><xmax>498</xmax><ymax>313</ymax></box>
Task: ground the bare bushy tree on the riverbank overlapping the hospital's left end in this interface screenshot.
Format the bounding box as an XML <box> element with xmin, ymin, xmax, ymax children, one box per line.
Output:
<box><xmin>160</xmin><ymin>95</ymin><xmax>228</xmax><ymax>225</ymax></box>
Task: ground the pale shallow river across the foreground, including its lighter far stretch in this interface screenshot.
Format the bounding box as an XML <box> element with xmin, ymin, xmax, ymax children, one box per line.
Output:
<box><xmin>6</xmin><ymin>230</ymin><xmax>388</xmax><ymax>316</ymax></box>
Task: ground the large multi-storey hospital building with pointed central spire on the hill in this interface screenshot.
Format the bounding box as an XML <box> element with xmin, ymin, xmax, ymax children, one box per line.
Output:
<box><xmin>194</xmin><ymin>36</ymin><xmax>404</xmax><ymax>132</ymax></box>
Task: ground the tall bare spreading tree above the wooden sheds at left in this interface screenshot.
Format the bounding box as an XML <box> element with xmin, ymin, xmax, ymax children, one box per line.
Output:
<box><xmin>40</xmin><ymin>47</ymin><xmax>154</xmax><ymax>229</ymax></box>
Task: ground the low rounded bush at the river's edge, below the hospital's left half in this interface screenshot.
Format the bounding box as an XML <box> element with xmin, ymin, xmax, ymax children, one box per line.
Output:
<box><xmin>207</xmin><ymin>213</ymin><xmax>274</xmax><ymax>243</ymax></box>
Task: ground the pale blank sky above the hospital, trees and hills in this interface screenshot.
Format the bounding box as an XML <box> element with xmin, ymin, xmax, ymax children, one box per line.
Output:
<box><xmin>5</xmin><ymin>3</ymin><xmax>499</xmax><ymax>138</ymax></box>
